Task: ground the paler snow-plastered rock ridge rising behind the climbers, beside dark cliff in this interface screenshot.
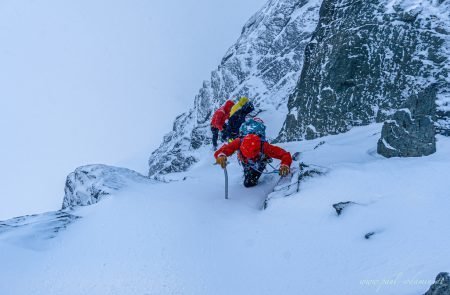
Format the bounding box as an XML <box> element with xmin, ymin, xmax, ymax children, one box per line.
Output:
<box><xmin>149</xmin><ymin>0</ymin><xmax>321</xmax><ymax>176</ymax></box>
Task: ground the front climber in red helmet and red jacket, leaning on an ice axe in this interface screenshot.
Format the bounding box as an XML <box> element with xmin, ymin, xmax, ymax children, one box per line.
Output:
<box><xmin>214</xmin><ymin>134</ymin><xmax>292</xmax><ymax>187</ymax></box>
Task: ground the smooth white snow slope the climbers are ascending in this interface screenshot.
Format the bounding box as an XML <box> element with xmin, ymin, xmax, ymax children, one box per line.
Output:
<box><xmin>0</xmin><ymin>124</ymin><xmax>450</xmax><ymax>295</ymax></box>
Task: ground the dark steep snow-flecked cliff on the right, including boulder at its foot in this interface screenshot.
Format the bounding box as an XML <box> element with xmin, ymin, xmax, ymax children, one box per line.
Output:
<box><xmin>278</xmin><ymin>0</ymin><xmax>450</xmax><ymax>147</ymax></box>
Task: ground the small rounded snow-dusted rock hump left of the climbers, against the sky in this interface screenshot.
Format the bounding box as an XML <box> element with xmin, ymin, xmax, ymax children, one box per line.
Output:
<box><xmin>62</xmin><ymin>165</ymin><xmax>150</xmax><ymax>209</ymax></box>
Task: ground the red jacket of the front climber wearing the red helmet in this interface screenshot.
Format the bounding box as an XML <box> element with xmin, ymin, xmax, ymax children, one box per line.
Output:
<box><xmin>214</xmin><ymin>138</ymin><xmax>292</xmax><ymax>167</ymax></box>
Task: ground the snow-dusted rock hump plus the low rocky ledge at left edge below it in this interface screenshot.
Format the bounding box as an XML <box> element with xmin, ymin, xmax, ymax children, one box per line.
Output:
<box><xmin>0</xmin><ymin>165</ymin><xmax>151</xmax><ymax>249</ymax></box>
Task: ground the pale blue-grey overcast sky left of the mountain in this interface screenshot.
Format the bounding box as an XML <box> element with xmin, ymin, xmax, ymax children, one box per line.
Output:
<box><xmin>0</xmin><ymin>0</ymin><xmax>266</xmax><ymax>220</ymax></box>
